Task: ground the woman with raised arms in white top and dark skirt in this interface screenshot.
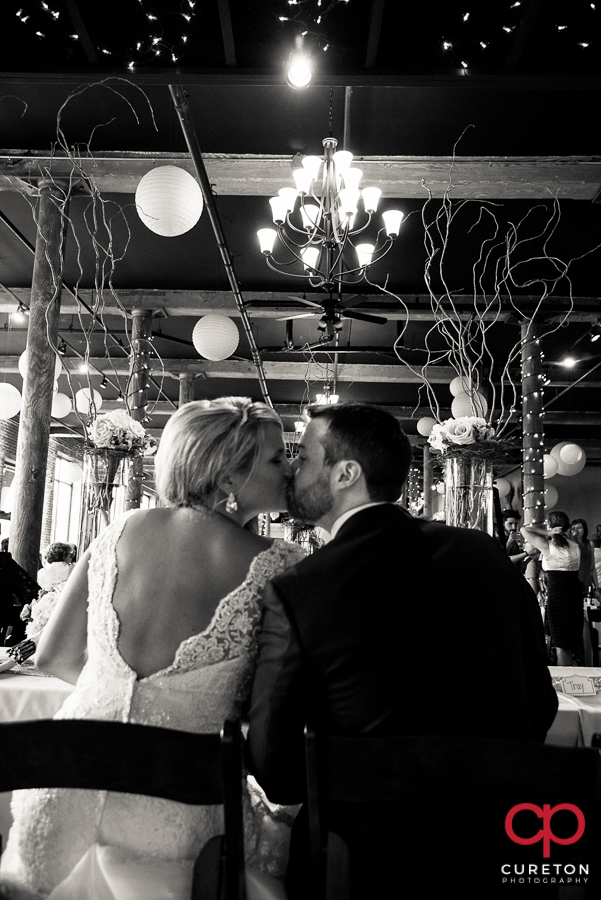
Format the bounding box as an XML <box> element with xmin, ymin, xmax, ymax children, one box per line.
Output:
<box><xmin>521</xmin><ymin>510</ymin><xmax>580</xmax><ymax>666</ymax></box>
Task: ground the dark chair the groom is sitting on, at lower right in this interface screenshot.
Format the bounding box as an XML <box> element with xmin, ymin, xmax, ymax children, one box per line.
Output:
<box><xmin>305</xmin><ymin>725</ymin><xmax>601</xmax><ymax>900</ymax></box>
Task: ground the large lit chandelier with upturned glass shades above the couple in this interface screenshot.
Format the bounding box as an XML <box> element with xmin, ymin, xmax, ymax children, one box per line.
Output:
<box><xmin>257</xmin><ymin>137</ymin><xmax>403</xmax><ymax>293</ymax></box>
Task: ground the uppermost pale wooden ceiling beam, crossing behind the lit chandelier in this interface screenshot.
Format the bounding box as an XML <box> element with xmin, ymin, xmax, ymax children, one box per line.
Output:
<box><xmin>0</xmin><ymin>149</ymin><xmax>601</xmax><ymax>202</ymax></box>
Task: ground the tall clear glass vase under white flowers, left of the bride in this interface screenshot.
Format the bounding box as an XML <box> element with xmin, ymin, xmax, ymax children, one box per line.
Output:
<box><xmin>79</xmin><ymin>448</ymin><xmax>131</xmax><ymax>555</ymax></box>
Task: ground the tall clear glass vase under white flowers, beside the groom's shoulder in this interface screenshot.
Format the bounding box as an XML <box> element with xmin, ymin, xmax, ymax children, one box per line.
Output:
<box><xmin>444</xmin><ymin>453</ymin><xmax>493</xmax><ymax>535</ymax></box>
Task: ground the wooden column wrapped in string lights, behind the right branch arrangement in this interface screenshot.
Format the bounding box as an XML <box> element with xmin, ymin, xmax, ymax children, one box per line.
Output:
<box><xmin>521</xmin><ymin>320</ymin><xmax>545</xmax><ymax>525</ymax></box>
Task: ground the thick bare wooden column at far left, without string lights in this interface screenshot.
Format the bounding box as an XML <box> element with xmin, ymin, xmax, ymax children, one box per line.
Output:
<box><xmin>10</xmin><ymin>179</ymin><xmax>68</xmax><ymax>578</ymax></box>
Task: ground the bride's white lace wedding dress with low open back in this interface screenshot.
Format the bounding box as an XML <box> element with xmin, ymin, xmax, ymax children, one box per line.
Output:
<box><xmin>0</xmin><ymin>513</ymin><xmax>304</xmax><ymax>900</ymax></box>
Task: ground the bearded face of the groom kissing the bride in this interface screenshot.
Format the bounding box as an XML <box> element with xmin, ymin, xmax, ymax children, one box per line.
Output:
<box><xmin>288</xmin><ymin>419</ymin><xmax>334</xmax><ymax>525</ymax></box>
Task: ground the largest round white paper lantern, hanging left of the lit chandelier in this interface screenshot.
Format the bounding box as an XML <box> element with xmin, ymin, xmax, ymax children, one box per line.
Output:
<box><xmin>136</xmin><ymin>166</ymin><xmax>203</xmax><ymax>237</ymax></box>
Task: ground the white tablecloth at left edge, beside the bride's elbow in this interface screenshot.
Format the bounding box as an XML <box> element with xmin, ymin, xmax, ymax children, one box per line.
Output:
<box><xmin>0</xmin><ymin>670</ymin><xmax>73</xmax><ymax>843</ymax></box>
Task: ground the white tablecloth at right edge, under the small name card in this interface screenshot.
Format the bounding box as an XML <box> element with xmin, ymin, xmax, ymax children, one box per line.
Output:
<box><xmin>546</xmin><ymin>666</ymin><xmax>601</xmax><ymax>747</ymax></box>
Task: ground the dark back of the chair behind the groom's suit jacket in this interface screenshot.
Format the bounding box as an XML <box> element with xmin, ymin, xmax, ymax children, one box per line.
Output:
<box><xmin>305</xmin><ymin>724</ymin><xmax>601</xmax><ymax>900</ymax></box>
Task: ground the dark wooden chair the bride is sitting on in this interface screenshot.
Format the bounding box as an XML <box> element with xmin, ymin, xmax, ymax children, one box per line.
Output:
<box><xmin>0</xmin><ymin>719</ymin><xmax>246</xmax><ymax>900</ymax></box>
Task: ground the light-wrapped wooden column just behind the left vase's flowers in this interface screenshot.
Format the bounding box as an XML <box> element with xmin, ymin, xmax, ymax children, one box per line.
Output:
<box><xmin>125</xmin><ymin>309</ymin><xmax>154</xmax><ymax>509</ymax></box>
